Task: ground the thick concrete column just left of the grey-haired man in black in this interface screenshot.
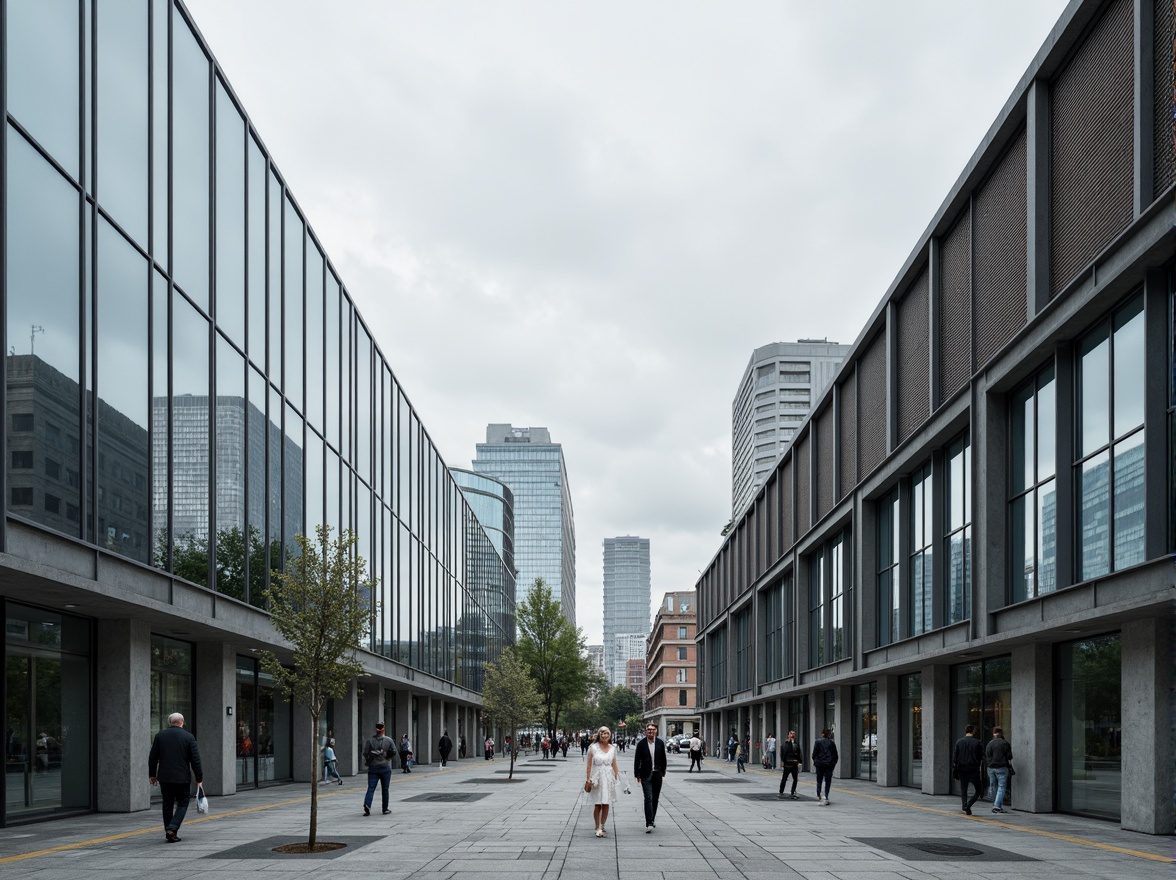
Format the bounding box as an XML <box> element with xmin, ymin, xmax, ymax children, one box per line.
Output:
<box><xmin>95</xmin><ymin>620</ymin><xmax>151</xmax><ymax>813</ymax></box>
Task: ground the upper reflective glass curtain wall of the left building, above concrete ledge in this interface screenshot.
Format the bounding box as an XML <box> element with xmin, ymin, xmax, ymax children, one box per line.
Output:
<box><xmin>2</xmin><ymin>0</ymin><xmax>514</xmax><ymax>691</ymax></box>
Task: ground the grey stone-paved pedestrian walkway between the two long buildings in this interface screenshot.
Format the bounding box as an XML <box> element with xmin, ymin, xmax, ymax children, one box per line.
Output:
<box><xmin>0</xmin><ymin>749</ymin><xmax>1176</xmax><ymax>880</ymax></box>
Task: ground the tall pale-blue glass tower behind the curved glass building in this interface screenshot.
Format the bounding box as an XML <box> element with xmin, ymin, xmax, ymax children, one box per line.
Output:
<box><xmin>474</xmin><ymin>425</ymin><xmax>576</xmax><ymax>626</ymax></box>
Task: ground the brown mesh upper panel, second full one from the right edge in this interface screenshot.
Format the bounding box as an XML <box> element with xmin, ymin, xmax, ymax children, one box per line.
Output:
<box><xmin>973</xmin><ymin>129</ymin><xmax>1028</xmax><ymax>367</ymax></box>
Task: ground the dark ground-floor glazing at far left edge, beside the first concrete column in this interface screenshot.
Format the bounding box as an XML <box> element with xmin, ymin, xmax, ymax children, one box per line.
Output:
<box><xmin>4</xmin><ymin>602</ymin><xmax>94</xmax><ymax>822</ymax></box>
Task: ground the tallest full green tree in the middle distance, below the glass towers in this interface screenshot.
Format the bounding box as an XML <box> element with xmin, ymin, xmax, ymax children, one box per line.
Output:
<box><xmin>515</xmin><ymin>578</ymin><xmax>594</xmax><ymax>738</ymax></box>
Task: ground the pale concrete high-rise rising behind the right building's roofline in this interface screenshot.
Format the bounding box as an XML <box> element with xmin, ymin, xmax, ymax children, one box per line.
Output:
<box><xmin>731</xmin><ymin>339</ymin><xmax>850</xmax><ymax>516</ymax></box>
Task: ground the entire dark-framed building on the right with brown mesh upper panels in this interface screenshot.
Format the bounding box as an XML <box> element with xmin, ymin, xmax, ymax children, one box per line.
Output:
<box><xmin>696</xmin><ymin>0</ymin><xmax>1176</xmax><ymax>834</ymax></box>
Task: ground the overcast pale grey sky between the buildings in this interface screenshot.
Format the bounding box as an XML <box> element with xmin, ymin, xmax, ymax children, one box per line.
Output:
<box><xmin>187</xmin><ymin>0</ymin><xmax>1065</xmax><ymax>642</ymax></box>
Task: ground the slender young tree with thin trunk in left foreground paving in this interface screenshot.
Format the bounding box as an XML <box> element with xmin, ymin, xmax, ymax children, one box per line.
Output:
<box><xmin>261</xmin><ymin>526</ymin><xmax>377</xmax><ymax>852</ymax></box>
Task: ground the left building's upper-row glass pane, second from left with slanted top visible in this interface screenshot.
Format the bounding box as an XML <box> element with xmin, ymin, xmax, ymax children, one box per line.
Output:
<box><xmin>216</xmin><ymin>80</ymin><xmax>245</xmax><ymax>347</ymax></box>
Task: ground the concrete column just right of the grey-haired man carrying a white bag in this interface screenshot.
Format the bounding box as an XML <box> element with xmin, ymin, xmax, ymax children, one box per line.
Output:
<box><xmin>189</xmin><ymin>641</ymin><xmax>236</xmax><ymax>796</ymax></box>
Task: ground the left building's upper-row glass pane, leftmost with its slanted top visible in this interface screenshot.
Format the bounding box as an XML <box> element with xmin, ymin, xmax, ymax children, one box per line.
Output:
<box><xmin>172</xmin><ymin>16</ymin><xmax>209</xmax><ymax>312</ymax></box>
